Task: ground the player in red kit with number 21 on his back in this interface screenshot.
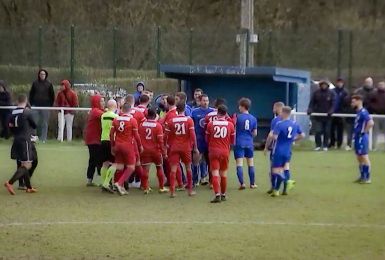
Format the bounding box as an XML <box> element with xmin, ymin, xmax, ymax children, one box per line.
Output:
<box><xmin>165</xmin><ymin>103</ymin><xmax>199</xmax><ymax>198</ymax></box>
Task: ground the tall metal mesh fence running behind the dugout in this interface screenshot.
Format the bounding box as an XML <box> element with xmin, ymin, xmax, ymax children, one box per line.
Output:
<box><xmin>0</xmin><ymin>26</ymin><xmax>385</xmax><ymax>85</ymax></box>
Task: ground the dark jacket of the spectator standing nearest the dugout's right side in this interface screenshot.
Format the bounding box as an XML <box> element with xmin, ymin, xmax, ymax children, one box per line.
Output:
<box><xmin>307</xmin><ymin>84</ymin><xmax>335</xmax><ymax>115</ymax></box>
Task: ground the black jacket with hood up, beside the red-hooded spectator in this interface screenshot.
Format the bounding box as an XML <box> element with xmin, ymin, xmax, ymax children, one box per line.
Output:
<box><xmin>29</xmin><ymin>69</ymin><xmax>55</xmax><ymax>107</ymax></box>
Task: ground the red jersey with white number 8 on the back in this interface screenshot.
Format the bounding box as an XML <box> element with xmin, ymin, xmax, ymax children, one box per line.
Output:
<box><xmin>110</xmin><ymin>114</ymin><xmax>141</xmax><ymax>146</ymax></box>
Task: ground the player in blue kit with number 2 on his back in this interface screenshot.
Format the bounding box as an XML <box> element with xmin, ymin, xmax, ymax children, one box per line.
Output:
<box><xmin>271</xmin><ymin>106</ymin><xmax>305</xmax><ymax>197</ymax></box>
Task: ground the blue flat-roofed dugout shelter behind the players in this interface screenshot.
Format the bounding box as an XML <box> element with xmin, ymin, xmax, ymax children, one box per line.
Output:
<box><xmin>160</xmin><ymin>65</ymin><xmax>310</xmax><ymax>141</ymax></box>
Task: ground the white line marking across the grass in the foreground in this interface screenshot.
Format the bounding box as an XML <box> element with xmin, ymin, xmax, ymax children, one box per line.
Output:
<box><xmin>0</xmin><ymin>221</ymin><xmax>385</xmax><ymax>229</ymax></box>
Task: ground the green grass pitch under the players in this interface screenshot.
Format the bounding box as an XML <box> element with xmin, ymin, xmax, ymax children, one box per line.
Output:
<box><xmin>0</xmin><ymin>142</ymin><xmax>385</xmax><ymax>259</ymax></box>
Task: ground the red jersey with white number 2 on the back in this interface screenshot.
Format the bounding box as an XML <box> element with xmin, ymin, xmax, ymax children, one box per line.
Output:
<box><xmin>139</xmin><ymin>120</ymin><xmax>163</xmax><ymax>152</ymax></box>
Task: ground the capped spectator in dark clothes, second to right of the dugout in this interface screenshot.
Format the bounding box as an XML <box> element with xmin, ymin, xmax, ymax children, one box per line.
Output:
<box><xmin>329</xmin><ymin>78</ymin><xmax>348</xmax><ymax>149</ymax></box>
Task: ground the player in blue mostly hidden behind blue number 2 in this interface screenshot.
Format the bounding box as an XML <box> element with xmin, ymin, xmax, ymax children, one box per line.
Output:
<box><xmin>263</xmin><ymin>102</ymin><xmax>284</xmax><ymax>194</ymax></box>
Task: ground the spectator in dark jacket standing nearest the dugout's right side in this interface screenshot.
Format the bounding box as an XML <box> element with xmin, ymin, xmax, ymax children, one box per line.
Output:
<box><xmin>307</xmin><ymin>80</ymin><xmax>335</xmax><ymax>151</ymax></box>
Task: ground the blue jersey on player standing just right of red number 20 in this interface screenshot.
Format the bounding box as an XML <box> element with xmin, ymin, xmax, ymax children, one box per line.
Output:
<box><xmin>235</xmin><ymin>113</ymin><xmax>257</xmax><ymax>147</ymax></box>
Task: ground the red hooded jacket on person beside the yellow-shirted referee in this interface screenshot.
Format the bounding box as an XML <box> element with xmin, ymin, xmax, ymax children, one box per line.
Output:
<box><xmin>84</xmin><ymin>95</ymin><xmax>104</xmax><ymax>145</ymax></box>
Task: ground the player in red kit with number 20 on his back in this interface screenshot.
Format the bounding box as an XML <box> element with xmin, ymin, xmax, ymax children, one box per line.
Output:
<box><xmin>206</xmin><ymin>105</ymin><xmax>235</xmax><ymax>203</ymax></box>
